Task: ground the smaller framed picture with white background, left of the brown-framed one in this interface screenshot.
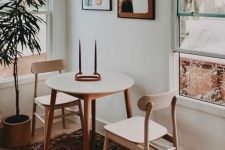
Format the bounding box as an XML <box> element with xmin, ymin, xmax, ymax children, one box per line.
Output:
<box><xmin>82</xmin><ymin>0</ymin><xmax>112</xmax><ymax>11</ymax></box>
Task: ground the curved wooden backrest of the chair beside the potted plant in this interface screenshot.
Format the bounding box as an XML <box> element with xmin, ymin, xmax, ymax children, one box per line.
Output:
<box><xmin>30</xmin><ymin>59</ymin><xmax>64</xmax><ymax>74</ymax></box>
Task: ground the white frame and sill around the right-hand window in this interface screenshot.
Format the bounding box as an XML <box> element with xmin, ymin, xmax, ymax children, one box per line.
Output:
<box><xmin>170</xmin><ymin>0</ymin><xmax>225</xmax><ymax>117</ymax></box>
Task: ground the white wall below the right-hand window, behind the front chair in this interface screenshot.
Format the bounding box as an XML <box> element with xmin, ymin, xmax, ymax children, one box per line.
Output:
<box><xmin>154</xmin><ymin>99</ymin><xmax>225</xmax><ymax>150</ymax></box>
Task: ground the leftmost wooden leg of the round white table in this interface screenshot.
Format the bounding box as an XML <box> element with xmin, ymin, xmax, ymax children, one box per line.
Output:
<box><xmin>44</xmin><ymin>89</ymin><xmax>57</xmax><ymax>150</ymax></box>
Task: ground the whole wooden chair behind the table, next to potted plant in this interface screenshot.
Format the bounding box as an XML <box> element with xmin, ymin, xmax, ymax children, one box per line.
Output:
<box><xmin>31</xmin><ymin>59</ymin><xmax>83</xmax><ymax>136</ymax></box>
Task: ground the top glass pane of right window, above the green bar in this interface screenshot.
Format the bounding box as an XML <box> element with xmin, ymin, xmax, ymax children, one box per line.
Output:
<box><xmin>178</xmin><ymin>0</ymin><xmax>225</xmax><ymax>14</ymax></box>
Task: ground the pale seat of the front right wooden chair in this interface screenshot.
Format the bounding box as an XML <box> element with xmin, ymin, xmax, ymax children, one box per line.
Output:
<box><xmin>104</xmin><ymin>117</ymin><xmax>167</xmax><ymax>143</ymax></box>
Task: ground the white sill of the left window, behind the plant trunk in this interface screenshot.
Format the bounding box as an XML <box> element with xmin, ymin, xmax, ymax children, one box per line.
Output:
<box><xmin>0</xmin><ymin>73</ymin><xmax>54</xmax><ymax>90</ymax></box>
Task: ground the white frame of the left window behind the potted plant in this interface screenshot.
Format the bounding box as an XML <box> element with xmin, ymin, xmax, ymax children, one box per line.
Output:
<box><xmin>0</xmin><ymin>0</ymin><xmax>53</xmax><ymax>86</ymax></box>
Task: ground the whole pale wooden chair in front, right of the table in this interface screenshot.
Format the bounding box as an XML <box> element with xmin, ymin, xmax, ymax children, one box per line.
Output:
<box><xmin>104</xmin><ymin>92</ymin><xmax>178</xmax><ymax>150</ymax></box>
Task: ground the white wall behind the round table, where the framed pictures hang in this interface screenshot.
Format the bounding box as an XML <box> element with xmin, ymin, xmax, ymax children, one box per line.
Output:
<box><xmin>68</xmin><ymin>0</ymin><xmax>170</xmax><ymax>122</ymax></box>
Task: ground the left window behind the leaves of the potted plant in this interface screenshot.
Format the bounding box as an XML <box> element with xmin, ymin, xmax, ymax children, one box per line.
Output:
<box><xmin>0</xmin><ymin>1</ymin><xmax>50</xmax><ymax>80</ymax></box>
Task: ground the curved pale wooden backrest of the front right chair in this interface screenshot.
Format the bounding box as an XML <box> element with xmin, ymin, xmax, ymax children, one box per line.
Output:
<box><xmin>138</xmin><ymin>91</ymin><xmax>176</xmax><ymax>111</ymax></box>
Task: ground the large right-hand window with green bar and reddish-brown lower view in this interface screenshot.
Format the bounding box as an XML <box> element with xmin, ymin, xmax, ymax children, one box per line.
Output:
<box><xmin>175</xmin><ymin>0</ymin><xmax>225</xmax><ymax>106</ymax></box>
